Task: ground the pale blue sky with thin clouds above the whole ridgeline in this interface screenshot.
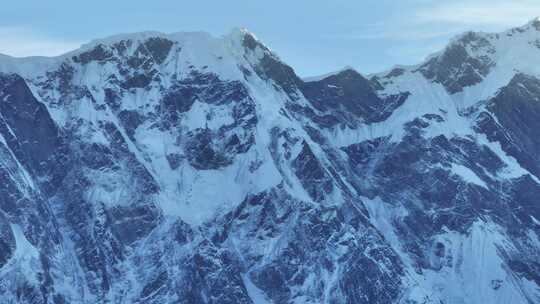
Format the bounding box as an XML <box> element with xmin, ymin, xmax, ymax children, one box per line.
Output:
<box><xmin>0</xmin><ymin>0</ymin><xmax>540</xmax><ymax>76</ymax></box>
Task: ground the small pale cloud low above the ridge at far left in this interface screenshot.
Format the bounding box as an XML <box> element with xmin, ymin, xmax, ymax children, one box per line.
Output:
<box><xmin>0</xmin><ymin>27</ymin><xmax>81</xmax><ymax>57</ymax></box>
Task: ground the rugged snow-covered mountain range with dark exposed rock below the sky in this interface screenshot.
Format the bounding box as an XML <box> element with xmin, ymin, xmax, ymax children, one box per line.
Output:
<box><xmin>0</xmin><ymin>20</ymin><xmax>540</xmax><ymax>304</ymax></box>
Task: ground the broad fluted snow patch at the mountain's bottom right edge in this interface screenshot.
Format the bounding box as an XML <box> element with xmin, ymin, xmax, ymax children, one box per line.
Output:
<box><xmin>417</xmin><ymin>221</ymin><xmax>527</xmax><ymax>304</ymax></box>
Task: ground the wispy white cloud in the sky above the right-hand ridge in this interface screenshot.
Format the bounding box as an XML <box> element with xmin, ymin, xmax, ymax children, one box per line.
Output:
<box><xmin>322</xmin><ymin>0</ymin><xmax>540</xmax><ymax>41</ymax></box>
